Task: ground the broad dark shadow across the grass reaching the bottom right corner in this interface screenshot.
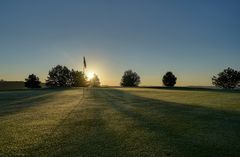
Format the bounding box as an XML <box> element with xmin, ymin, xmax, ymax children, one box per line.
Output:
<box><xmin>98</xmin><ymin>89</ymin><xmax>240</xmax><ymax>157</ymax></box>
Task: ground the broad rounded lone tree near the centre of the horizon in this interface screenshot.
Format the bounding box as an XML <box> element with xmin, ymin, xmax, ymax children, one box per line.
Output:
<box><xmin>120</xmin><ymin>70</ymin><xmax>141</xmax><ymax>87</ymax></box>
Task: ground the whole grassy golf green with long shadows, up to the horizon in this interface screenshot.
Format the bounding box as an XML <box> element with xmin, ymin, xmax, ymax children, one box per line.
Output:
<box><xmin>0</xmin><ymin>88</ymin><xmax>240</xmax><ymax>157</ymax></box>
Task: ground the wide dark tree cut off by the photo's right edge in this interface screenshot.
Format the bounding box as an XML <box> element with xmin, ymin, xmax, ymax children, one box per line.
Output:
<box><xmin>212</xmin><ymin>68</ymin><xmax>240</xmax><ymax>89</ymax></box>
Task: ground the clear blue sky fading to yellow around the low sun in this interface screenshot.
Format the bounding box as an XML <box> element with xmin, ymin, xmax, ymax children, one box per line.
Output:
<box><xmin>0</xmin><ymin>0</ymin><xmax>240</xmax><ymax>86</ymax></box>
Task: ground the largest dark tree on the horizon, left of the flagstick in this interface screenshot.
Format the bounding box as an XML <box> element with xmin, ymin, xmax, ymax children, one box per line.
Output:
<box><xmin>46</xmin><ymin>65</ymin><xmax>73</xmax><ymax>87</ymax></box>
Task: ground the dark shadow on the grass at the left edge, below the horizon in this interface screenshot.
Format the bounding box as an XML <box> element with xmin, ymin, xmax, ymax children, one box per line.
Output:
<box><xmin>0</xmin><ymin>89</ymin><xmax>63</xmax><ymax>117</ymax></box>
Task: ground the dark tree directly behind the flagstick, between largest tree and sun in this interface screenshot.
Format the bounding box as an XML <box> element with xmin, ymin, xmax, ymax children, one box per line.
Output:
<box><xmin>71</xmin><ymin>70</ymin><xmax>87</xmax><ymax>87</ymax></box>
